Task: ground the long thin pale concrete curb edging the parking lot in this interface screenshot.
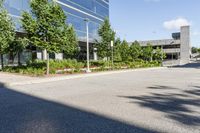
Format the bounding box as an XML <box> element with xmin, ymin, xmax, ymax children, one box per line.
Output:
<box><xmin>0</xmin><ymin>67</ymin><xmax>167</xmax><ymax>87</ymax></box>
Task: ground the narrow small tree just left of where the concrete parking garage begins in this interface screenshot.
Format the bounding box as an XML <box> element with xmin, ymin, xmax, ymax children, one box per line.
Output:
<box><xmin>120</xmin><ymin>40</ymin><xmax>131</xmax><ymax>61</ymax></box>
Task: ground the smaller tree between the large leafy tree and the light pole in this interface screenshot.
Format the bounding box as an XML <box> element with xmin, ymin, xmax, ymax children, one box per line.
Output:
<box><xmin>62</xmin><ymin>25</ymin><xmax>78</xmax><ymax>58</ymax></box>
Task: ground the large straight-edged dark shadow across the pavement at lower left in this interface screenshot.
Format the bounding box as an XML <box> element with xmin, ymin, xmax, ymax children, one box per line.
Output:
<box><xmin>0</xmin><ymin>83</ymin><xmax>156</xmax><ymax>133</ymax></box>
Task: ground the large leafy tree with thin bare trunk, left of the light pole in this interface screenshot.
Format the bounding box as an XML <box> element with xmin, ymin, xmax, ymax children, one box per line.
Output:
<box><xmin>22</xmin><ymin>0</ymin><xmax>66</xmax><ymax>74</ymax></box>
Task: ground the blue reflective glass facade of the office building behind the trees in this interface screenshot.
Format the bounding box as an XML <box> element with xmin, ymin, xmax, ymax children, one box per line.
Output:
<box><xmin>5</xmin><ymin>0</ymin><xmax>109</xmax><ymax>41</ymax></box>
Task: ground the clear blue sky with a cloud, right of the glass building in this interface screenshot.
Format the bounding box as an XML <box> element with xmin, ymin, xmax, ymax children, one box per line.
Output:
<box><xmin>110</xmin><ymin>0</ymin><xmax>200</xmax><ymax>47</ymax></box>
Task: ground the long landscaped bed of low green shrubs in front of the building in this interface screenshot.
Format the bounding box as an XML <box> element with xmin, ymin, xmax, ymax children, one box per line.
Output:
<box><xmin>3</xmin><ymin>59</ymin><xmax>161</xmax><ymax>76</ymax></box>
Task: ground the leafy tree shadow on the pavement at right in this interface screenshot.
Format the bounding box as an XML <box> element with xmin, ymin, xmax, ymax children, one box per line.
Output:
<box><xmin>119</xmin><ymin>86</ymin><xmax>200</xmax><ymax>126</ymax></box>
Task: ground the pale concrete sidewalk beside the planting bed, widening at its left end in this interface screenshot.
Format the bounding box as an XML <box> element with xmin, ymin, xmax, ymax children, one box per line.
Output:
<box><xmin>0</xmin><ymin>67</ymin><xmax>165</xmax><ymax>86</ymax></box>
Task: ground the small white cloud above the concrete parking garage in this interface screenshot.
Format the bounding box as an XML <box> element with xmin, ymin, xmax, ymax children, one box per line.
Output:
<box><xmin>163</xmin><ymin>17</ymin><xmax>191</xmax><ymax>30</ymax></box>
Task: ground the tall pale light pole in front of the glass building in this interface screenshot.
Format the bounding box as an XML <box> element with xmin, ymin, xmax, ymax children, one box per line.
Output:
<box><xmin>84</xmin><ymin>18</ymin><xmax>91</xmax><ymax>73</ymax></box>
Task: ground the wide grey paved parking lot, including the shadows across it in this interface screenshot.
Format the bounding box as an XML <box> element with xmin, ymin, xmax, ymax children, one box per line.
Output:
<box><xmin>0</xmin><ymin>66</ymin><xmax>200</xmax><ymax>133</ymax></box>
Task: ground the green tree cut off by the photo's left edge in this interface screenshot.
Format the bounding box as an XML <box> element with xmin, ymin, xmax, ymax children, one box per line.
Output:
<box><xmin>0</xmin><ymin>0</ymin><xmax>15</xmax><ymax>69</ymax></box>
